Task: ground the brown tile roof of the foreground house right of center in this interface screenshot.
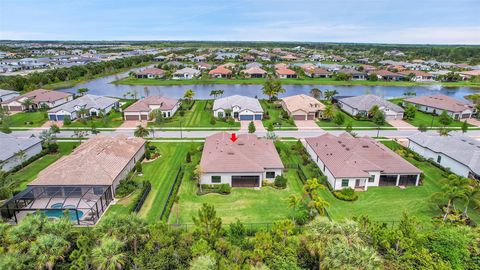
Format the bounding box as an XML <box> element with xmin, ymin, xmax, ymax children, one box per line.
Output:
<box><xmin>305</xmin><ymin>133</ymin><xmax>421</xmax><ymax>178</ymax></box>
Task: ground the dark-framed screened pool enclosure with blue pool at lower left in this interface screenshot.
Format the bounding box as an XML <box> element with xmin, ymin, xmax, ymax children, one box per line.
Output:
<box><xmin>0</xmin><ymin>186</ymin><xmax>113</xmax><ymax>225</ymax></box>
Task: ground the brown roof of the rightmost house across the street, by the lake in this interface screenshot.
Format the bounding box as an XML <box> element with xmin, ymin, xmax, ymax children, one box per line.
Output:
<box><xmin>404</xmin><ymin>94</ymin><xmax>472</xmax><ymax>112</ymax></box>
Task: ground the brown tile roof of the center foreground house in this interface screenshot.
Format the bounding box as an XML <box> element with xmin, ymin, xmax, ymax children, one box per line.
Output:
<box><xmin>200</xmin><ymin>132</ymin><xmax>284</xmax><ymax>173</ymax></box>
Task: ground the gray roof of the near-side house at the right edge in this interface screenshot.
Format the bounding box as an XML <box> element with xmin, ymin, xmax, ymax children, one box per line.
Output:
<box><xmin>408</xmin><ymin>132</ymin><xmax>480</xmax><ymax>175</ymax></box>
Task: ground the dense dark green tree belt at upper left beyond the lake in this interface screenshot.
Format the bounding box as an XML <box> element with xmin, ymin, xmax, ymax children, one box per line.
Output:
<box><xmin>0</xmin><ymin>55</ymin><xmax>153</xmax><ymax>91</ymax></box>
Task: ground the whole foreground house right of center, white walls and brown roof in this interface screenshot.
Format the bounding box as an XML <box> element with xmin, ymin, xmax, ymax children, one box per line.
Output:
<box><xmin>305</xmin><ymin>133</ymin><xmax>422</xmax><ymax>190</ymax></box>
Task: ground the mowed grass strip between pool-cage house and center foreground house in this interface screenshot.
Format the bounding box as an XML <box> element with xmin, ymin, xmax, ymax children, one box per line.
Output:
<box><xmin>135</xmin><ymin>143</ymin><xmax>200</xmax><ymax>222</ymax></box>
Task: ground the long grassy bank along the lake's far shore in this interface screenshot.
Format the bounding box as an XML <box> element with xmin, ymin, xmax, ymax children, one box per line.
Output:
<box><xmin>113</xmin><ymin>78</ymin><xmax>480</xmax><ymax>88</ymax></box>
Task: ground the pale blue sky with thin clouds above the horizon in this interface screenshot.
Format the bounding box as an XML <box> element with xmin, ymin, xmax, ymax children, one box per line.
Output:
<box><xmin>0</xmin><ymin>0</ymin><xmax>480</xmax><ymax>44</ymax></box>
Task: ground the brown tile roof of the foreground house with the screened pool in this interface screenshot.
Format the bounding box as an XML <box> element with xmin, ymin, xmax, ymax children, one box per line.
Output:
<box><xmin>30</xmin><ymin>135</ymin><xmax>145</xmax><ymax>186</ymax></box>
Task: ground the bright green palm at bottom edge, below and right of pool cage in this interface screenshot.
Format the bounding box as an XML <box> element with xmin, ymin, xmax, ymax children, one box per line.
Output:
<box><xmin>92</xmin><ymin>237</ymin><xmax>127</xmax><ymax>270</ymax></box>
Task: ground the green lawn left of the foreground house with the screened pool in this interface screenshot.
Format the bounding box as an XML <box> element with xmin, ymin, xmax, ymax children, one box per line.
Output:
<box><xmin>12</xmin><ymin>142</ymin><xmax>78</xmax><ymax>191</ymax></box>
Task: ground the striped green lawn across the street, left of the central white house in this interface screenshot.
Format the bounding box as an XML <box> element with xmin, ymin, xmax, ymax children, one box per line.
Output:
<box><xmin>148</xmin><ymin>100</ymin><xmax>240</xmax><ymax>129</ymax></box>
